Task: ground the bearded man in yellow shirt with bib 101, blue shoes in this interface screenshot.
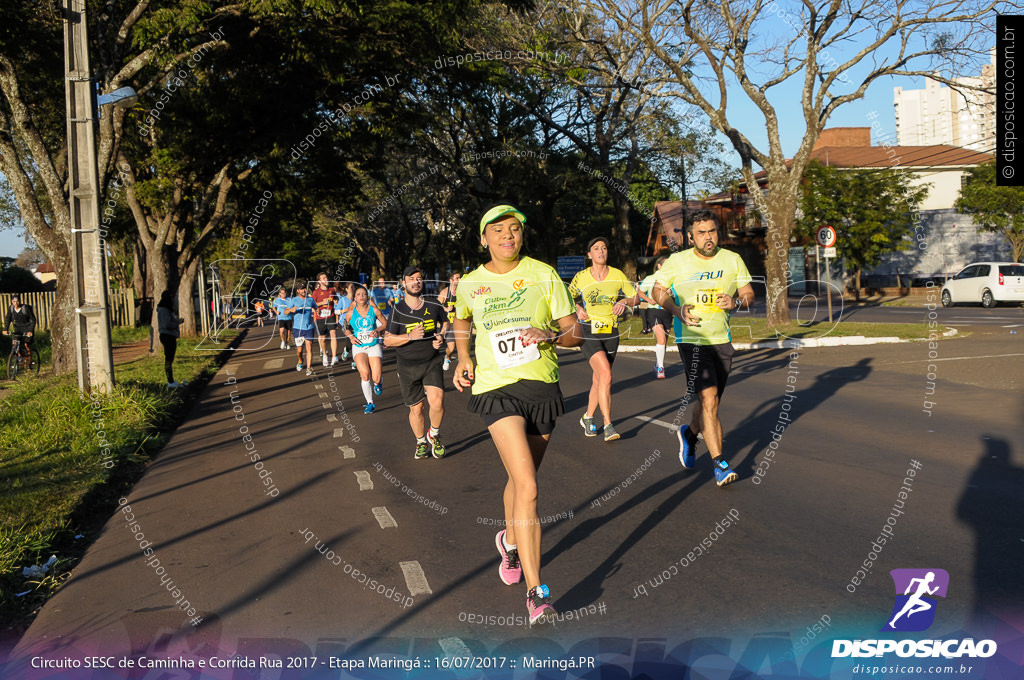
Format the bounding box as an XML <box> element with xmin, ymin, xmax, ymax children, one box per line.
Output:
<box><xmin>651</xmin><ymin>210</ymin><xmax>754</xmax><ymax>486</ymax></box>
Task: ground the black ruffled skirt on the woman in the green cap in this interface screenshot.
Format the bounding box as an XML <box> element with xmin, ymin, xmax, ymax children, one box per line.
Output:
<box><xmin>469</xmin><ymin>380</ymin><xmax>565</xmax><ymax>434</ymax></box>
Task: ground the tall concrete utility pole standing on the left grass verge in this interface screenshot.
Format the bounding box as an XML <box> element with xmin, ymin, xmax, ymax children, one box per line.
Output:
<box><xmin>62</xmin><ymin>0</ymin><xmax>114</xmax><ymax>393</ymax></box>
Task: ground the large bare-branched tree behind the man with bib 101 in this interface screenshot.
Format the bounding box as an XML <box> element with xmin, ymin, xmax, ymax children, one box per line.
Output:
<box><xmin>570</xmin><ymin>0</ymin><xmax>1007</xmax><ymax>325</ymax></box>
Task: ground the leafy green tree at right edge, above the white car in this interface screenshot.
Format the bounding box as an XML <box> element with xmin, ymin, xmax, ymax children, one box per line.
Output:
<box><xmin>956</xmin><ymin>161</ymin><xmax>1024</xmax><ymax>262</ymax></box>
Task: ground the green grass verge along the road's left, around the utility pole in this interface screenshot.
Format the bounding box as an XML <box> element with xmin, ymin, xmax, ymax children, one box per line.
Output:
<box><xmin>0</xmin><ymin>329</ymin><xmax>237</xmax><ymax>629</ymax></box>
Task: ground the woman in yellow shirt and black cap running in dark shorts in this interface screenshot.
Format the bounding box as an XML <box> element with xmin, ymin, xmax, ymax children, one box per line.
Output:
<box><xmin>569</xmin><ymin>237</ymin><xmax>640</xmax><ymax>441</ymax></box>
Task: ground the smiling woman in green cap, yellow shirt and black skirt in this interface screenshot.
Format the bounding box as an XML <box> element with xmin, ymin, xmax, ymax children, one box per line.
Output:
<box><xmin>455</xmin><ymin>204</ymin><xmax>580</xmax><ymax>625</ymax></box>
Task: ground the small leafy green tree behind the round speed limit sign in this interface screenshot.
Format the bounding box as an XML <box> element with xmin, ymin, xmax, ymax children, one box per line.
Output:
<box><xmin>796</xmin><ymin>161</ymin><xmax>928</xmax><ymax>298</ymax></box>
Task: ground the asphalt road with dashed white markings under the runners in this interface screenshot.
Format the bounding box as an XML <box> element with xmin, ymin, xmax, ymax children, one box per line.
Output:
<box><xmin>0</xmin><ymin>327</ymin><xmax>1024</xmax><ymax>678</ymax></box>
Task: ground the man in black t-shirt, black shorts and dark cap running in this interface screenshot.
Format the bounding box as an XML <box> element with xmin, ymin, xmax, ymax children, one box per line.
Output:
<box><xmin>384</xmin><ymin>267</ymin><xmax>447</xmax><ymax>460</ymax></box>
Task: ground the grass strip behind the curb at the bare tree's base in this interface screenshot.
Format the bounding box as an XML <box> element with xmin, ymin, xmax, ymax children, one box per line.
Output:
<box><xmin>620</xmin><ymin>314</ymin><xmax>942</xmax><ymax>345</ymax></box>
